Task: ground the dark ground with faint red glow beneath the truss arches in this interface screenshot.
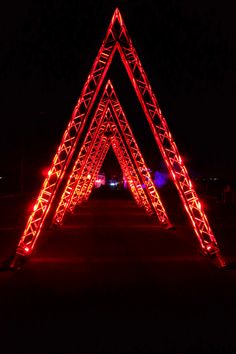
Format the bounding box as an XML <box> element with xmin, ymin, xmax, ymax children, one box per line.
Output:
<box><xmin>0</xmin><ymin>191</ymin><xmax>236</xmax><ymax>354</ymax></box>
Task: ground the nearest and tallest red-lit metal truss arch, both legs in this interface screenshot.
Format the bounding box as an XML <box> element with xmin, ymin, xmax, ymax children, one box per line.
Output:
<box><xmin>11</xmin><ymin>9</ymin><xmax>223</xmax><ymax>263</ymax></box>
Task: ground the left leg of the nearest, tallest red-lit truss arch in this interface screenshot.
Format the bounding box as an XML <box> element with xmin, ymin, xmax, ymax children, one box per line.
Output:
<box><xmin>11</xmin><ymin>11</ymin><xmax>121</xmax><ymax>256</ymax></box>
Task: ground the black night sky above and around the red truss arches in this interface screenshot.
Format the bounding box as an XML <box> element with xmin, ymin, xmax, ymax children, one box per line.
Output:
<box><xmin>0</xmin><ymin>0</ymin><xmax>236</xmax><ymax>192</ymax></box>
